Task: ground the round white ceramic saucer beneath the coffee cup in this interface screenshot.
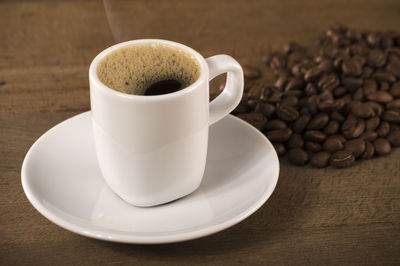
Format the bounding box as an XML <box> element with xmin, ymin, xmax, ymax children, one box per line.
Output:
<box><xmin>21</xmin><ymin>112</ymin><xmax>279</xmax><ymax>244</ymax></box>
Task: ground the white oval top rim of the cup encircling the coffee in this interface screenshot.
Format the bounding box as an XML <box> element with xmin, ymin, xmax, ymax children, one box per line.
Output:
<box><xmin>89</xmin><ymin>39</ymin><xmax>208</xmax><ymax>101</ymax></box>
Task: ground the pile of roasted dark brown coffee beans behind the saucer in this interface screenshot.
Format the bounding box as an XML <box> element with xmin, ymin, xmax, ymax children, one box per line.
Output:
<box><xmin>233</xmin><ymin>24</ymin><xmax>400</xmax><ymax>168</ymax></box>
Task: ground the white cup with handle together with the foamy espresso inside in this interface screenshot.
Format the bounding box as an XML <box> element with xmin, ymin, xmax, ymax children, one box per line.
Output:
<box><xmin>89</xmin><ymin>39</ymin><xmax>243</xmax><ymax>207</ymax></box>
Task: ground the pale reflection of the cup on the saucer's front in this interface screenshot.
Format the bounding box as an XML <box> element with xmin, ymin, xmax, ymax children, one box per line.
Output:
<box><xmin>92</xmin><ymin>186</ymin><xmax>214</xmax><ymax>233</ymax></box>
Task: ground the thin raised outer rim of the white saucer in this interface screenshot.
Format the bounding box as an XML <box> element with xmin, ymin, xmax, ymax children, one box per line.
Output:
<box><xmin>21</xmin><ymin>111</ymin><xmax>280</xmax><ymax>244</ymax></box>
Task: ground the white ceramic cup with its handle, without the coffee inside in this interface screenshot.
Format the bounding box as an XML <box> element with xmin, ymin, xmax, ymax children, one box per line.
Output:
<box><xmin>89</xmin><ymin>39</ymin><xmax>243</xmax><ymax>207</ymax></box>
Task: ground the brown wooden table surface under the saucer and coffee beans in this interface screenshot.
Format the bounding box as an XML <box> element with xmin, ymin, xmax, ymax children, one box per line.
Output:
<box><xmin>0</xmin><ymin>0</ymin><xmax>400</xmax><ymax>265</ymax></box>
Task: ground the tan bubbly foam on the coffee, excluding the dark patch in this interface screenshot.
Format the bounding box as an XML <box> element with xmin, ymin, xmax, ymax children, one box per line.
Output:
<box><xmin>97</xmin><ymin>43</ymin><xmax>200</xmax><ymax>95</ymax></box>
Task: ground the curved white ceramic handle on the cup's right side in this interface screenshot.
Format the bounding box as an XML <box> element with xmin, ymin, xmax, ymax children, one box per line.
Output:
<box><xmin>206</xmin><ymin>55</ymin><xmax>243</xmax><ymax>125</ymax></box>
